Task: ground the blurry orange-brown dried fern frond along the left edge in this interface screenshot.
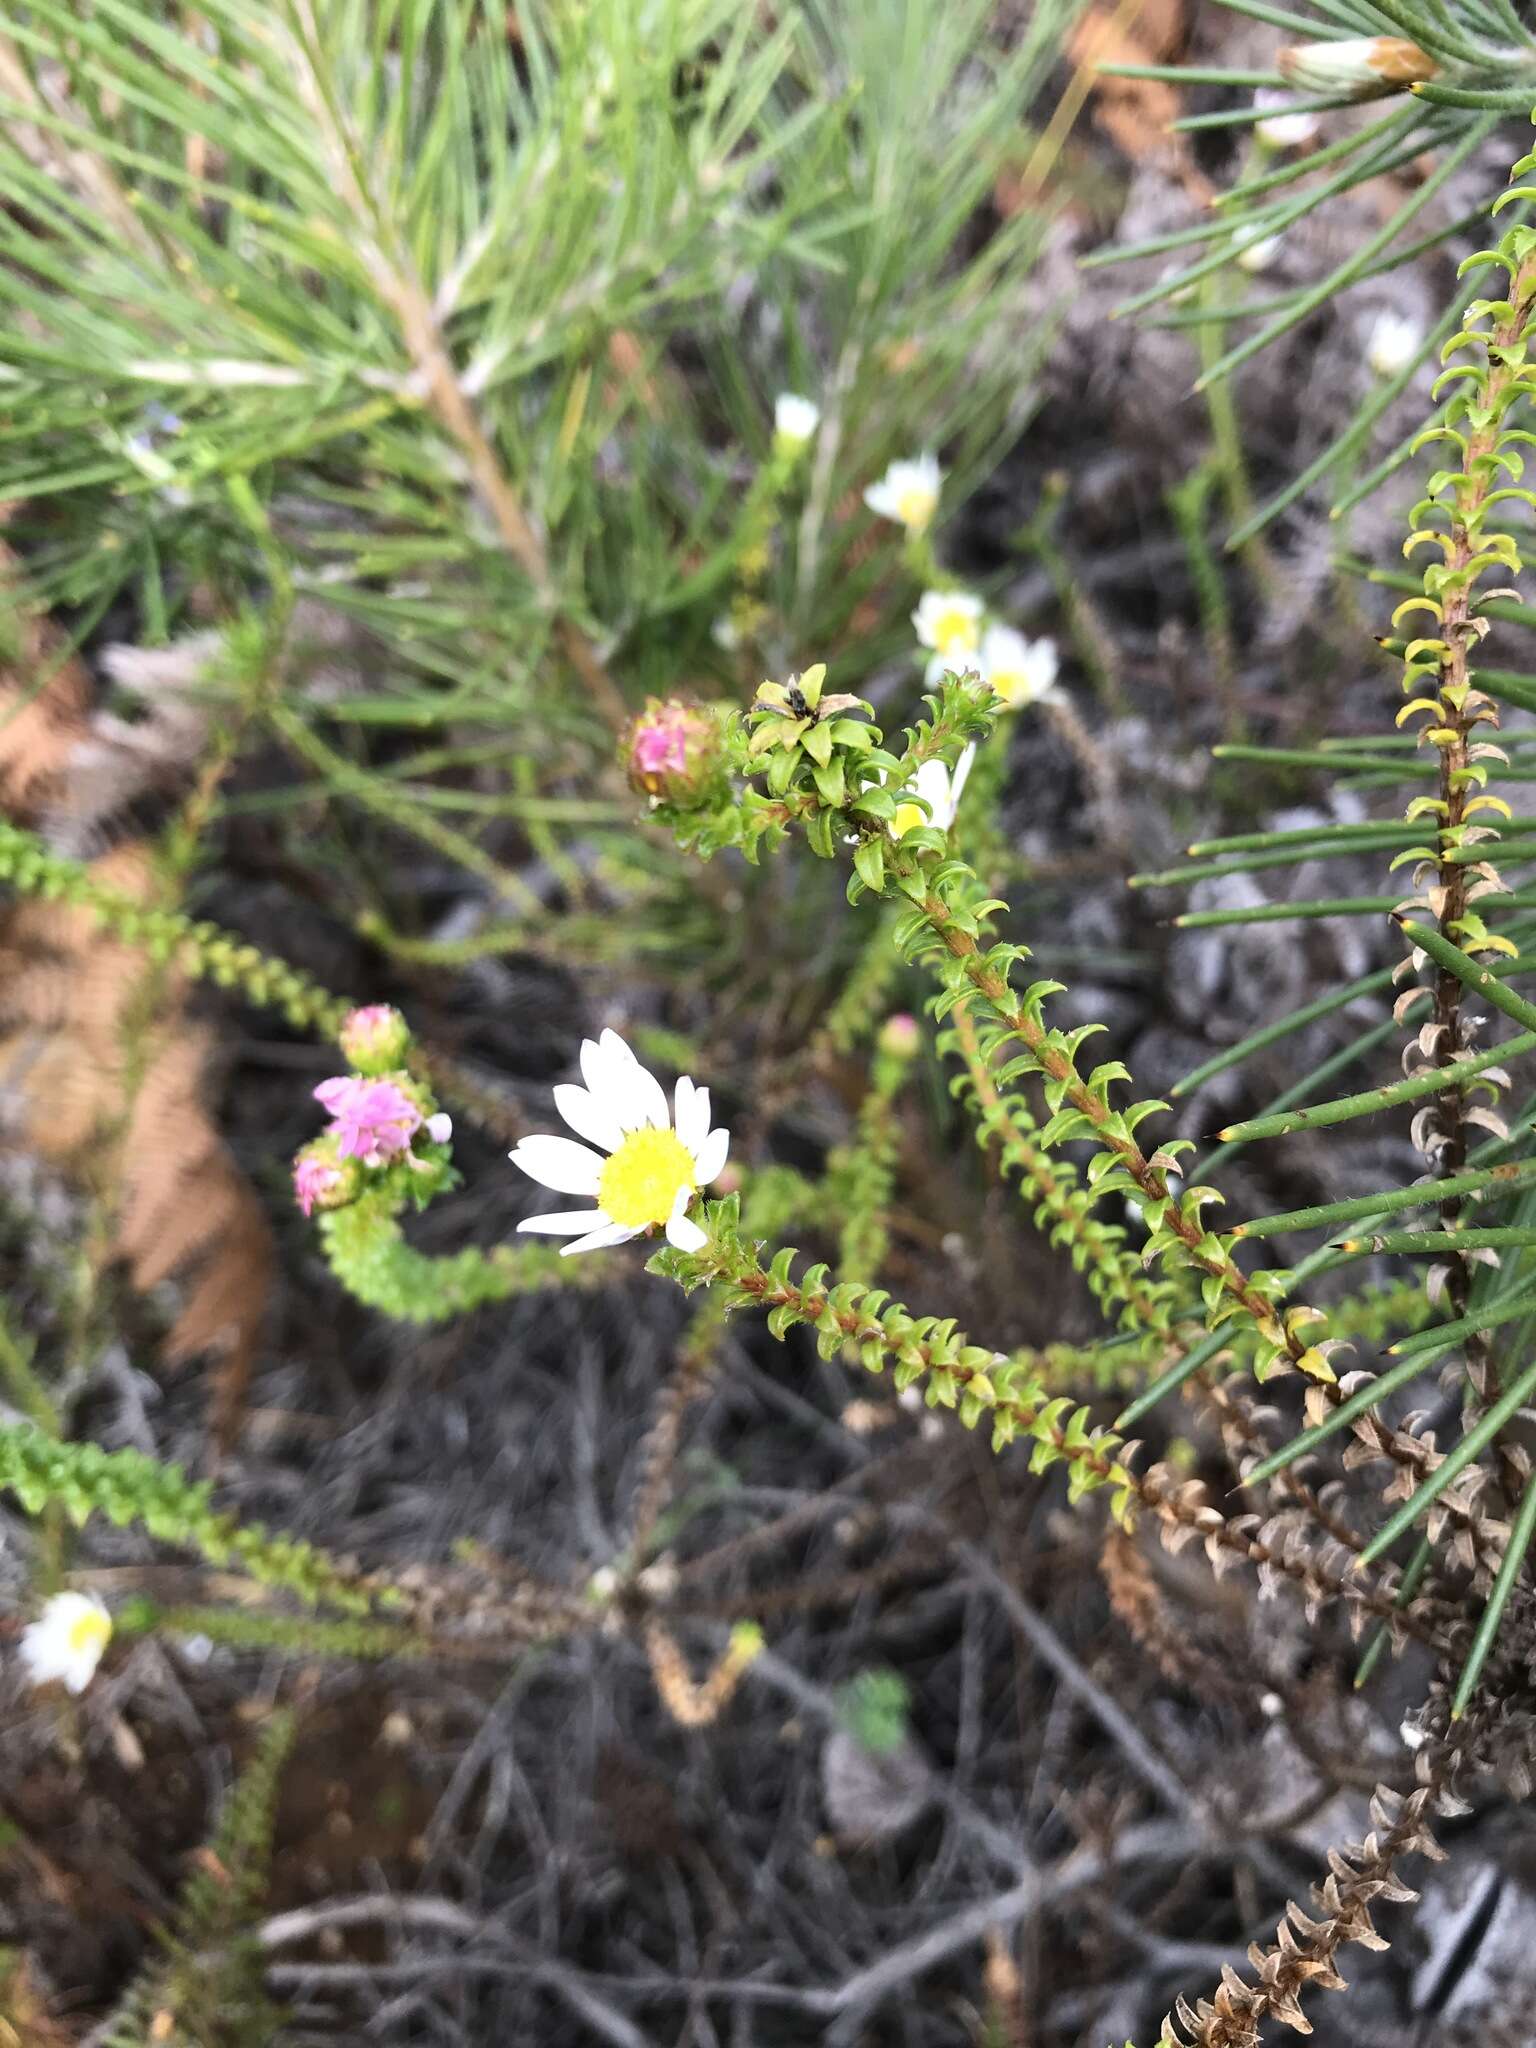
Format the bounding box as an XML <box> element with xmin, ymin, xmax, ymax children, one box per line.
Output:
<box><xmin>0</xmin><ymin>581</ymin><xmax>272</xmax><ymax>1444</ymax></box>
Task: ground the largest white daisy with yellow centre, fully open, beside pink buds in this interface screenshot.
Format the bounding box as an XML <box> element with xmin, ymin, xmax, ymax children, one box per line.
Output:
<box><xmin>508</xmin><ymin>1030</ymin><xmax>731</xmax><ymax>1257</ymax></box>
